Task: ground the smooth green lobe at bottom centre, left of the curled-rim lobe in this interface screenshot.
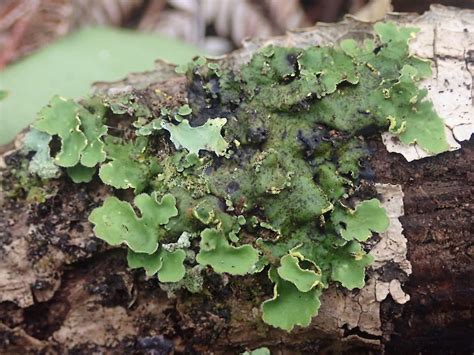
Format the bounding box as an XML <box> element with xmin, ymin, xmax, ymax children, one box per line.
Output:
<box><xmin>196</xmin><ymin>228</ymin><xmax>258</xmax><ymax>275</ymax></box>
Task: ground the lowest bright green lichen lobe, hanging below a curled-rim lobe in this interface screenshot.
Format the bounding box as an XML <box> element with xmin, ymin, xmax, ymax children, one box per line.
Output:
<box><xmin>262</xmin><ymin>269</ymin><xmax>321</xmax><ymax>332</ymax></box>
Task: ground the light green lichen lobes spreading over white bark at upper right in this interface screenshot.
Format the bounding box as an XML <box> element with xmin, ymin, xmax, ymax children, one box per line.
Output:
<box><xmin>341</xmin><ymin>23</ymin><xmax>449</xmax><ymax>153</ymax></box>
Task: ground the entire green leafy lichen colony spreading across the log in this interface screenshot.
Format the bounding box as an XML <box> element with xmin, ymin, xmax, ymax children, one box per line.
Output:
<box><xmin>19</xmin><ymin>23</ymin><xmax>447</xmax><ymax>331</ymax></box>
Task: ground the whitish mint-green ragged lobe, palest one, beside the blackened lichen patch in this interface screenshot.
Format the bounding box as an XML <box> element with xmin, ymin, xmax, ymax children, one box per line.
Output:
<box><xmin>162</xmin><ymin>118</ymin><xmax>228</xmax><ymax>155</ymax></box>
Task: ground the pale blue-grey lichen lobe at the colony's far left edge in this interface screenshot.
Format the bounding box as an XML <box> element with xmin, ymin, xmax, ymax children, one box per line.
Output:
<box><xmin>23</xmin><ymin>129</ymin><xmax>61</xmax><ymax>179</ymax></box>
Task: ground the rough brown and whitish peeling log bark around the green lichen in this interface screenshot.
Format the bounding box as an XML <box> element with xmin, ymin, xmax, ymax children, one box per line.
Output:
<box><xmin>0</xmin><ymin>7</ymin><xmax>474</xmax><ymax>354</ymax></box>
